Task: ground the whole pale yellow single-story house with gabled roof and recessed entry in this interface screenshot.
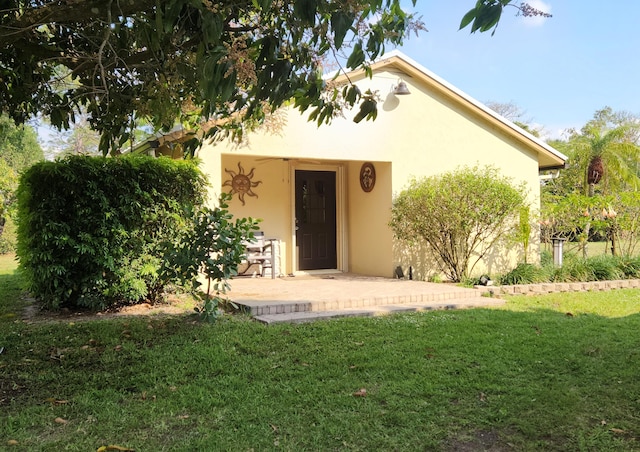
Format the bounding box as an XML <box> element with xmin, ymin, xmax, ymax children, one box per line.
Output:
<box><xmin>149</xmin><ymin>51</ymin><xmax>566</xmax><ymax>279</ymax></box>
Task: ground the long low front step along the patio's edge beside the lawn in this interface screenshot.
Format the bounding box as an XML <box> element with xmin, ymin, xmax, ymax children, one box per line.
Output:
<box><xmin>253</xmin><ymin>296</ymin><xmax>504</xmax><ymax>325</ymax></box>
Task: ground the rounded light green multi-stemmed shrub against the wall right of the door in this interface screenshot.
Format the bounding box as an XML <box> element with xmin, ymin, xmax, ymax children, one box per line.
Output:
<box><xmin>391</xmin><ymin>167</ymin><xmax>525</xmax><ymax>281</ymax></box>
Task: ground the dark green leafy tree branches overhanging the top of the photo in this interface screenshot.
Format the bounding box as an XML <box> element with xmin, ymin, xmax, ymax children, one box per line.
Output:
<box><xmin>0</xmin><ymin>0</ymin><xmax>540</xmax><ymax>153</ymax></box>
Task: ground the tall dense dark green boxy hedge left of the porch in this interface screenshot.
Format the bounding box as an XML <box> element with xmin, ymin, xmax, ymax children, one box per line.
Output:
<box><xmin>17</xmin><ymin>156</ymin><xmax>206</xmax><ymax>309</ymax></box>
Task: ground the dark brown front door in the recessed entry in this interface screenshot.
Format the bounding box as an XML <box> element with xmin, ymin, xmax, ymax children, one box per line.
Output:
<box><xmin>296</xmin><ymin>170</ymin><xmax>337</xmax><ymax>270</ymax></box>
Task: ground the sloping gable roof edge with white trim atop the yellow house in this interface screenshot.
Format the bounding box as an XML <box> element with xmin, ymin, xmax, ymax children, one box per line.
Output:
<box><xmin>327</xmin><ymin>50</ymin><xmax>568</xmax><ymax>170</ymax></box>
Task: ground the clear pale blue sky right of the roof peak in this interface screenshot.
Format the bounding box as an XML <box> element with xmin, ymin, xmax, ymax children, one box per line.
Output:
<box><xmin>400</xmin><ymin>0</ymin><xmax>640</xmax><ymax>138</ymax></box>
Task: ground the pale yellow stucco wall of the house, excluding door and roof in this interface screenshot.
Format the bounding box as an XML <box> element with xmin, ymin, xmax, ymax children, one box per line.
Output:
<box><xmin>194</xmin><ymin>62</ymin><xmax>552</xmax><ymax>279</ymax></box>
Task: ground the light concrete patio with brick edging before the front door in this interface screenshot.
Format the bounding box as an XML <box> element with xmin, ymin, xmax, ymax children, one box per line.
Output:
<box><xmin>228</xmin><ymin>273</ymin><xmax>504</xmax><ymax>324</ymax></box>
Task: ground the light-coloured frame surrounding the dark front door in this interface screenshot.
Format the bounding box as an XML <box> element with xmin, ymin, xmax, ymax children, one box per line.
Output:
<box><xmin>289</xmin><ymin>161</ymin><xmax>348</xmax><ymax>275</ymax></box>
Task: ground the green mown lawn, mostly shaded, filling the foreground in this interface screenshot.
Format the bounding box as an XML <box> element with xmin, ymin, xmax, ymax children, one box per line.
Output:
<box><xmin>0</xmin><ymin>256</ymin><xmax>640</xmax><ymax>451</ymax></box>
